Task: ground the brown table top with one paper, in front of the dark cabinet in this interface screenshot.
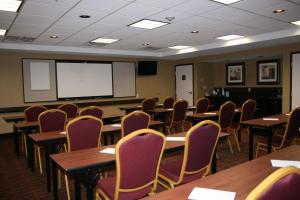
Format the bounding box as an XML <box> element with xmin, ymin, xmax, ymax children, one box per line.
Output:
<box><xmin>241</xmin><ymin>113</ymin><xmax>289</xmax><ymax>127</ymax></box>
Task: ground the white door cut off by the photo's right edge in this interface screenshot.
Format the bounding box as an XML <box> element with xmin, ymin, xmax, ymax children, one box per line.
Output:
<box><xmin>291</xmin><ymin>52</ymin><xmax>300</xmax><ymax>110</ymax></box>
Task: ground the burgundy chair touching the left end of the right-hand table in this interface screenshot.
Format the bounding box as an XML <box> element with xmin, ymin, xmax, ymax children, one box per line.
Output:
<box><xmin>231</xmin><ymin>99</ymin><xmax>256</xmax><ymax>152</ymax></box>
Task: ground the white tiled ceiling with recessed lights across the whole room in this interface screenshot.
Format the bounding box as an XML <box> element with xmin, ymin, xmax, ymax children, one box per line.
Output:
<box><xmin>0</xmin><ymin>0</ymin><xmax>300</xmax><ymax>59</ymax></box>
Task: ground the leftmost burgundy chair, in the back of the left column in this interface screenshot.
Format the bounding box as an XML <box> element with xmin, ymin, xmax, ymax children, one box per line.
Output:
<box><xmin>22</xmin><ymin>106</ymin><xmax>47</xmax><ymax>156</ymax></box>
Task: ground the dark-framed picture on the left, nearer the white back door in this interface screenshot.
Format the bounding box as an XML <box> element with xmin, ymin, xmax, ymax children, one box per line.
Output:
<box><xmin>226</xmin><ymin>63</ymin><xmax>245</xmax><ymax>85</ymax></box>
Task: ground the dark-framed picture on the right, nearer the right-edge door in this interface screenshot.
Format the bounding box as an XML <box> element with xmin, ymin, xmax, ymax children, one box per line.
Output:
<box><xmin>257</xmin><ymin>60</ymin><xmax>279</xmax><ymax>84</ymax></box>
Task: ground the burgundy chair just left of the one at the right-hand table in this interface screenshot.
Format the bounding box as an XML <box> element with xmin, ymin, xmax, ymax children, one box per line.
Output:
<box><xmin>218</xmin><ymin>101</ymin><xmax>238</xmax><ymax>153</ymax></box>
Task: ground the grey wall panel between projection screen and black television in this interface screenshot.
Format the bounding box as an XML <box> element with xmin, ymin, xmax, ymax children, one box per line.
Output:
<box><xmin>113</xmin><ymin>62</ymin><xmax>136</xmax><ymax>97</ymax></box>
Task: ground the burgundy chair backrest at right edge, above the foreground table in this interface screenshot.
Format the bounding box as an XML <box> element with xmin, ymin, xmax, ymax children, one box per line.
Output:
<box><xmin>280</xmin><ymin>107</ymin><xmax>300</xmax><ymax>148</ymax></box>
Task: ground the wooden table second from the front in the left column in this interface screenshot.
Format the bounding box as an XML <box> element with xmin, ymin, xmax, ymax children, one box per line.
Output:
<box><xmin>27</xmin><ymin>120</ymin><xmax>164</xmax><ymax>192</ymax></box>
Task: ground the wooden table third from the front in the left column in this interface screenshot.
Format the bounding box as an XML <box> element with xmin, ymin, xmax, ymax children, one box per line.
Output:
<box><xmin>9</xmin><ymin>115</ymin><xmax>122</xmax><ymax>154</ymax></box>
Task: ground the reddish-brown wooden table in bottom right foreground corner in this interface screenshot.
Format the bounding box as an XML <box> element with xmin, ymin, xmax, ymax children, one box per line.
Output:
<box><xmin>144</xmin><ymin>145</ymin><xmax>300</xmax><ymax>200</ymax></box>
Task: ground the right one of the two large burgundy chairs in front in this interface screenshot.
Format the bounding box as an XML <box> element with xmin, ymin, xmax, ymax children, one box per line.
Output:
<box><xmin>158</xmin><ymin>120</ymin><xmax>221</xmax><ymax>189</ymax></box>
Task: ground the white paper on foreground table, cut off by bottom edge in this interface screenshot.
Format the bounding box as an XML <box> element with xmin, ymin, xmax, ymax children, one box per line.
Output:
<box><xmin>188</xmin><ymin>187</ymin><xmax>235</xmax><ymax>200</ymax></box>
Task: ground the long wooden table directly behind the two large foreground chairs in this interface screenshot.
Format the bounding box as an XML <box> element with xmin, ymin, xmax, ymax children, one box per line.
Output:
<box><xmin>50</xmin><ymin>133</ymin><xmax>228</xmax><ymax>200</ymax></box>
